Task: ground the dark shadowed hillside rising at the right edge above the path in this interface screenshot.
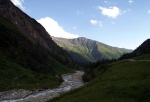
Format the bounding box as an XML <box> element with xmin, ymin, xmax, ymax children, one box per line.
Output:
<box><xmin>120</xmin><ymin>39</ymin><xmax>150</xmax><ymax>59</ymax></box>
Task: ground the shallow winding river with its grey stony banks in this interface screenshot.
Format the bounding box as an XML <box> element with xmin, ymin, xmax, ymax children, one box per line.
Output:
<box><xmin>0</xmin><ymin>71</ymin><xmax>84</xmax><ymax>102</ymax></box>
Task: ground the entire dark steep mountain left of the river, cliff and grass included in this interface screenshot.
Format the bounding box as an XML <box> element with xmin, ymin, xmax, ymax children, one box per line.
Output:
<box><xmin>0</xmin><ymin>0</ymin><xmax>76</xmax><ymax>91</ymax></box>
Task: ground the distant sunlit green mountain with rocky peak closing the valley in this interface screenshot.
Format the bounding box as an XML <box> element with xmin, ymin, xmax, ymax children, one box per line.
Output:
<box><xmin>52</xmin><ymin>37</ymin><xmax>131</xmax><ymax>63</ymax></box>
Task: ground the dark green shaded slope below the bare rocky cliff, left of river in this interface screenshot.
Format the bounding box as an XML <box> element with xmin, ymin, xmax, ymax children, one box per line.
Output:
<box><xmin>0</xmin><ymin>17</ymin><xmax>72</xmax><ymax>91</ymax></box>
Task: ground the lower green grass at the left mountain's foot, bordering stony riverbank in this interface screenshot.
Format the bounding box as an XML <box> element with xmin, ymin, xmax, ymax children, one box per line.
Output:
<box><xmin>0</xmin><ymin>56</ymin><xmax>62</xmax><ymax>91</ymax></box>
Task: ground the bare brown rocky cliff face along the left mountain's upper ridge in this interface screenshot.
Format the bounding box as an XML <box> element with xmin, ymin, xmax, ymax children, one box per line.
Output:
<box><xmin>0</xmin><ymin>0</ymin><xmax>59</xmax><ymax>51</ymax></box>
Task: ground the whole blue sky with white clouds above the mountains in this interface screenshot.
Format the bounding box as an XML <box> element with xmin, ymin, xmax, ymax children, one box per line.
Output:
<box><xmin>11</xmin><ymin>0</ymin><xmax>150</xmax><ymax>50</ymax></box>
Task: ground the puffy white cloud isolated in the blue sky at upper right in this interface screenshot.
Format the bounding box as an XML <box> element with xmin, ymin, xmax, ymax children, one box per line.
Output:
<box><xmin>98</xmin><ymin>6</ymin><xmax>121</xmax><ymax>18</ymax></box>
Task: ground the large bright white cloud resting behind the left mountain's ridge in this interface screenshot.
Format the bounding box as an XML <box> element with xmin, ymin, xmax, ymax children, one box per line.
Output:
<box><xmin>37</xmin><ymin>17</ymin><xmax>79</xmax><ymax>39</ymax></box>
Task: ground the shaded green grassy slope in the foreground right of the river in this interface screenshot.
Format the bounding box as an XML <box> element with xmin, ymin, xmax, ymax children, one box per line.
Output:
<box><xmin>49</xmin><ymin>53</ymin><xmax>150</xmax><ymax>102</ymax></box>
